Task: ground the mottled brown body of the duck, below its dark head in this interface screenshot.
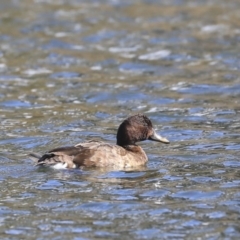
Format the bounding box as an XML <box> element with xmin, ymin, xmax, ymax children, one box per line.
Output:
<box><xmin>31</xmin><ymin>140</ymin><xmax>147</xmax><ymax>168</ymax></box>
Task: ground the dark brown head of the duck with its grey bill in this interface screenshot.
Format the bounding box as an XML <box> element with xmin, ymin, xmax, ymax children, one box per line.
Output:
<box><xmin>117</xmin><ymin>114</ymin><xmax>169</xmax><ymax>146</ymax></box>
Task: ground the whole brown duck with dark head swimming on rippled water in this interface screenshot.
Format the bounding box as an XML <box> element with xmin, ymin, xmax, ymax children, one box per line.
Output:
<box><xmin>30</xmin><ymin>114</ymin><xmax>169</xmax><ymax>169</ymax></box>
